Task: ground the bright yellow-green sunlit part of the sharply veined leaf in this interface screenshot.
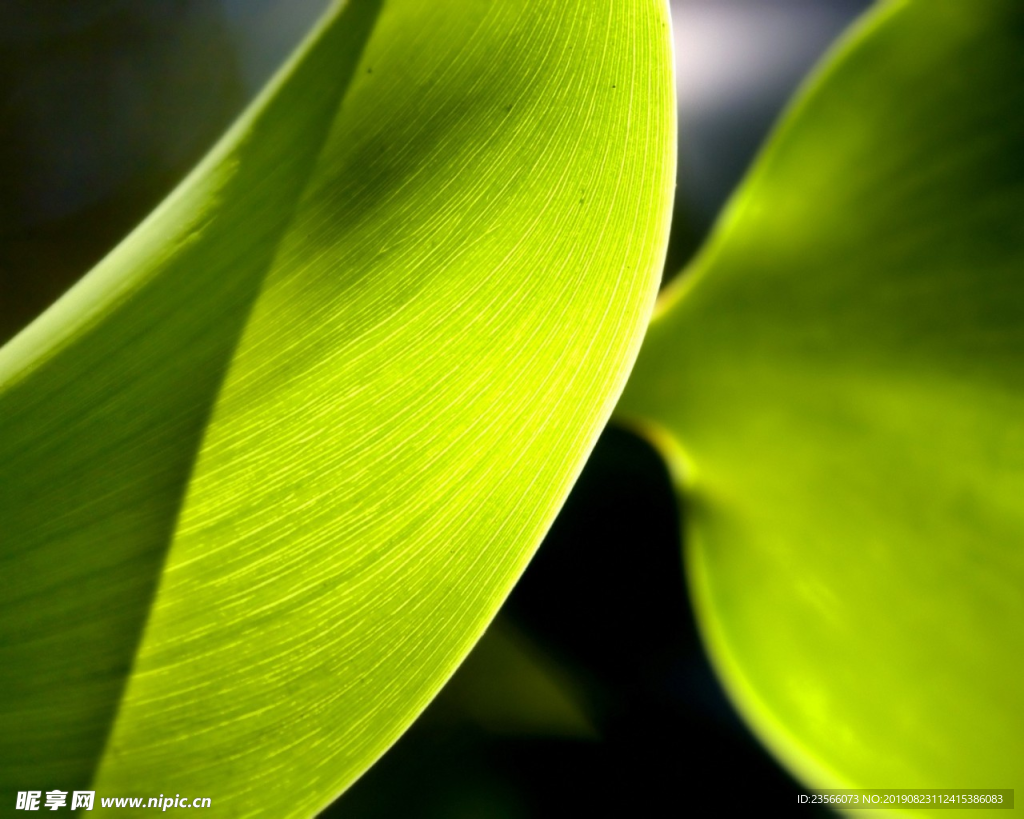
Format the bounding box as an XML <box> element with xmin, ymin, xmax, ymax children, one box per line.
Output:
<box><xmin>2</xmin><ymin>0</ymin><xmax>673</xmax><ymax>815</ymax></box>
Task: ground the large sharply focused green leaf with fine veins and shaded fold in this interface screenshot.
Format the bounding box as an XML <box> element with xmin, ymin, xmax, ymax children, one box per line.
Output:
<box><xmin>0</xmin><ymin>0</ymin><xmax>675</xmax><ymax>816</ymax></box>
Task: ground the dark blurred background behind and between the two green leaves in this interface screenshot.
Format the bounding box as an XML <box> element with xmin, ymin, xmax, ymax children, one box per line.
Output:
<box><xmin>0</xmin><ymin>0</ymin><xmax>869</xmax><ymax>819</ymax></box>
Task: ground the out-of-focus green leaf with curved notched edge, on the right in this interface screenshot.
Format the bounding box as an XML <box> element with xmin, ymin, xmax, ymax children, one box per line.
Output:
<box><xmin>618</xmin><ymin>0</ymin><xmax>1024</xmax><ymax>788</ymax></box>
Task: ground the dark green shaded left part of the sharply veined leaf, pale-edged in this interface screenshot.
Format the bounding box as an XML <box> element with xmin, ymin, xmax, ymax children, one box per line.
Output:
<box><xmin>0</xmin><ymin>3</ymin><xmax>385</xmax><ymax>788</ymax></box>
